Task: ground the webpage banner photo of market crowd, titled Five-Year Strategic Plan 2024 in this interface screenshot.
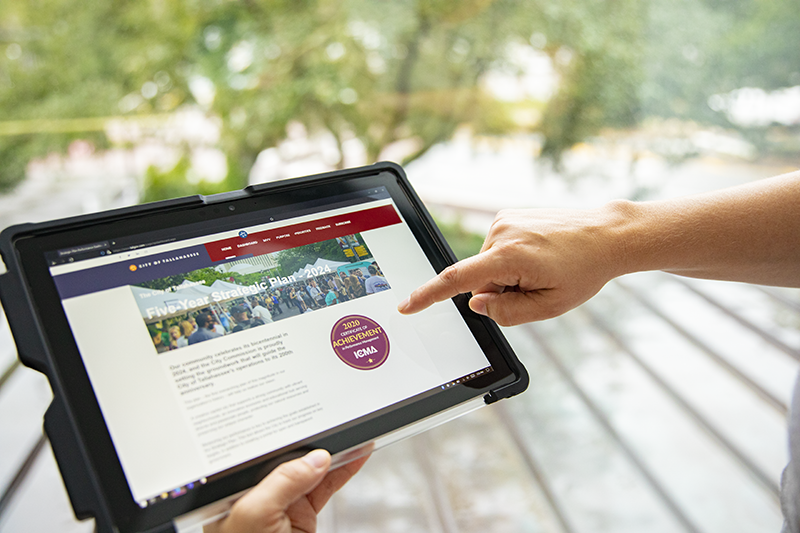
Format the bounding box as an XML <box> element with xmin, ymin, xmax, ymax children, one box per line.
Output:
<box><xmin>138</xmin><ymin>234</ymin><xmax>391</xmax><ymax>354</ymax></box>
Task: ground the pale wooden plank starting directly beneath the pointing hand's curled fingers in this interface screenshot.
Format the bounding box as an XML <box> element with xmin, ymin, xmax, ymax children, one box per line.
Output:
<box><xmin>531</xmin><ymin>298</ymin><xmax>785</xmax><ymax>532</ymax></box>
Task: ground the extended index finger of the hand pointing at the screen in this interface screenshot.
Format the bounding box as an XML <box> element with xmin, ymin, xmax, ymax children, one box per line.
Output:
<box><xmin>397</xmin><ymin>251</ymin><xmax>503</xmax><ymax>315</ymax></box>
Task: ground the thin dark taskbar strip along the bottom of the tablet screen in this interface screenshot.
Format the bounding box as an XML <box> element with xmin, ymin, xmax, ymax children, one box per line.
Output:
<box><xmin>136</xmin><ymin>366</ymin><xmax>493</xmax><ymax>509</ymax></box>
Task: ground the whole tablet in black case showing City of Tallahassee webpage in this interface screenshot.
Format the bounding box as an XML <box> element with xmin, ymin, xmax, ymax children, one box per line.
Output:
<box><xmin>0</xmin><ymin>163</ymin><xmax>527</xmax><ymax>533</ymax></box>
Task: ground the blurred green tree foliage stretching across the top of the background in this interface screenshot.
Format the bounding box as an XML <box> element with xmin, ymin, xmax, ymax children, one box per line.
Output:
<box><xmin>0</xmin><ymin>0</ymin><xmax>800</xmax><ymax>199</ymax></box>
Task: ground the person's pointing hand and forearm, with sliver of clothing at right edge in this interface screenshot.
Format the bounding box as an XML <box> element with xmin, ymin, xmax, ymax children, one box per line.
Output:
<box><xmin>398</xmin><ymin>172</ymin><xmax>800</xmax><ymax>533</ymax></box>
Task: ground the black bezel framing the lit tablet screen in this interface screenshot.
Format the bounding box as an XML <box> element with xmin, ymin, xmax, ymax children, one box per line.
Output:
<box><xmin>14</xmin><ymin>168</ymin><xmax>519</xmax><ymax>532</ymax></box>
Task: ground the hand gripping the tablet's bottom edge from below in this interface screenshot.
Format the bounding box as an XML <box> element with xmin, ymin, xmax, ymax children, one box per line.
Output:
<box><xmin>203</xmin><ymin>450</ymin><xmax>367</xmax><ymax>533</ymax></box>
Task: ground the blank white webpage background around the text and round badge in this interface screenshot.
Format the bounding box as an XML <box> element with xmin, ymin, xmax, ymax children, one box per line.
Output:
<box><xmin>57</xmin><ymin>206</ymin><xmax>488</xmax><ymax>501</ymax></box>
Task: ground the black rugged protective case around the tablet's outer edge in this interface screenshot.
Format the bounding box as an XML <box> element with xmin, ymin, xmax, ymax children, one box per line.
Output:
<box><xmin>0</xmin><ymin>162</ymin><xmax>529</xmax><ymax>533</ymax></box>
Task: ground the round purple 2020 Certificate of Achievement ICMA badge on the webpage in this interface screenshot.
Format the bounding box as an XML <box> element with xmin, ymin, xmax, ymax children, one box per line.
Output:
<box><xmin>331</xmin><ymin>315</ymin><xmax>389</xmax><ymax>370</ymax></box>
